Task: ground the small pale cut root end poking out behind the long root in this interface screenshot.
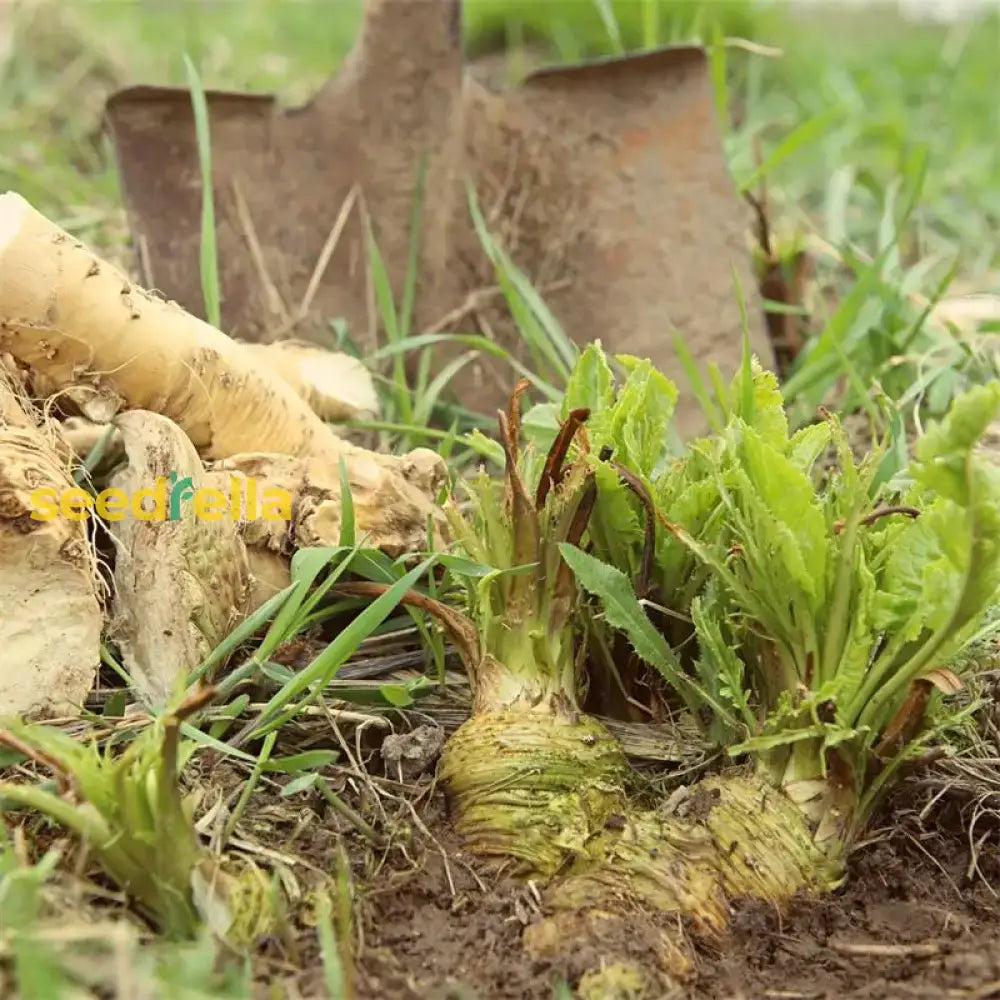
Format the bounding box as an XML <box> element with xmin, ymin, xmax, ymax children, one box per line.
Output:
<box><xmin>241</xmin><ymin>340</ymin><xmax>379</xmax><ymax>420</ymax></box>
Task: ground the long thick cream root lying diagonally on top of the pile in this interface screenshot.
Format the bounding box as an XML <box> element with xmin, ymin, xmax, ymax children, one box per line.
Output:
<box><xmin>0</xmin><ymin>192</ymin><xmax>446</xmax><ymax>548</ymax></box>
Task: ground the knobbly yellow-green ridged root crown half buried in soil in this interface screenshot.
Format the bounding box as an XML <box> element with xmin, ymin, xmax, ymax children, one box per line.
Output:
<box><xmin>450</xmin><ymin>706</ymin><xmax>840</xmax><ymax>996</ymax></box>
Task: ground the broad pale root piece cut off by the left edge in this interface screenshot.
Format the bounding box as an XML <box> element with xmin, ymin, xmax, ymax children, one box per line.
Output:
<box><xmin>0</xmin><ymin>360</ymin><xmax>103</xmax><ymax>718</ymax></box>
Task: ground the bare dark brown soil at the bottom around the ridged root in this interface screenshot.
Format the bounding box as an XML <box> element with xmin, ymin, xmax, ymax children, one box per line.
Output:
<box><xmin>348</xmin><ymin>788</ymin><xmax>1000</xmax><ymax>1000</ymax></box>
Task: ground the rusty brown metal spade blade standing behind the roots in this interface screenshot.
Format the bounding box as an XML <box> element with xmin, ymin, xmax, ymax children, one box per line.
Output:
<box><xmin>106</xmin><ymin>0</ymin><xmax>774</xmax><ymax>433</ymax></box>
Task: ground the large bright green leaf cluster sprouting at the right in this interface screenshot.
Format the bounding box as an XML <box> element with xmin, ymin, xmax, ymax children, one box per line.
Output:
<box><xmin>563</xmin><ymin>344</ymin><xmax>1000</xmax><ymax>820</ymax></box>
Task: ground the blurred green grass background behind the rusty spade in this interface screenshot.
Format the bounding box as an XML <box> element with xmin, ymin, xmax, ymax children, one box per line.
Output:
<box><xmin>0</xmin><ymin>0</ymin><xmax>1000</xmax><ymax>426</ymax></box>
